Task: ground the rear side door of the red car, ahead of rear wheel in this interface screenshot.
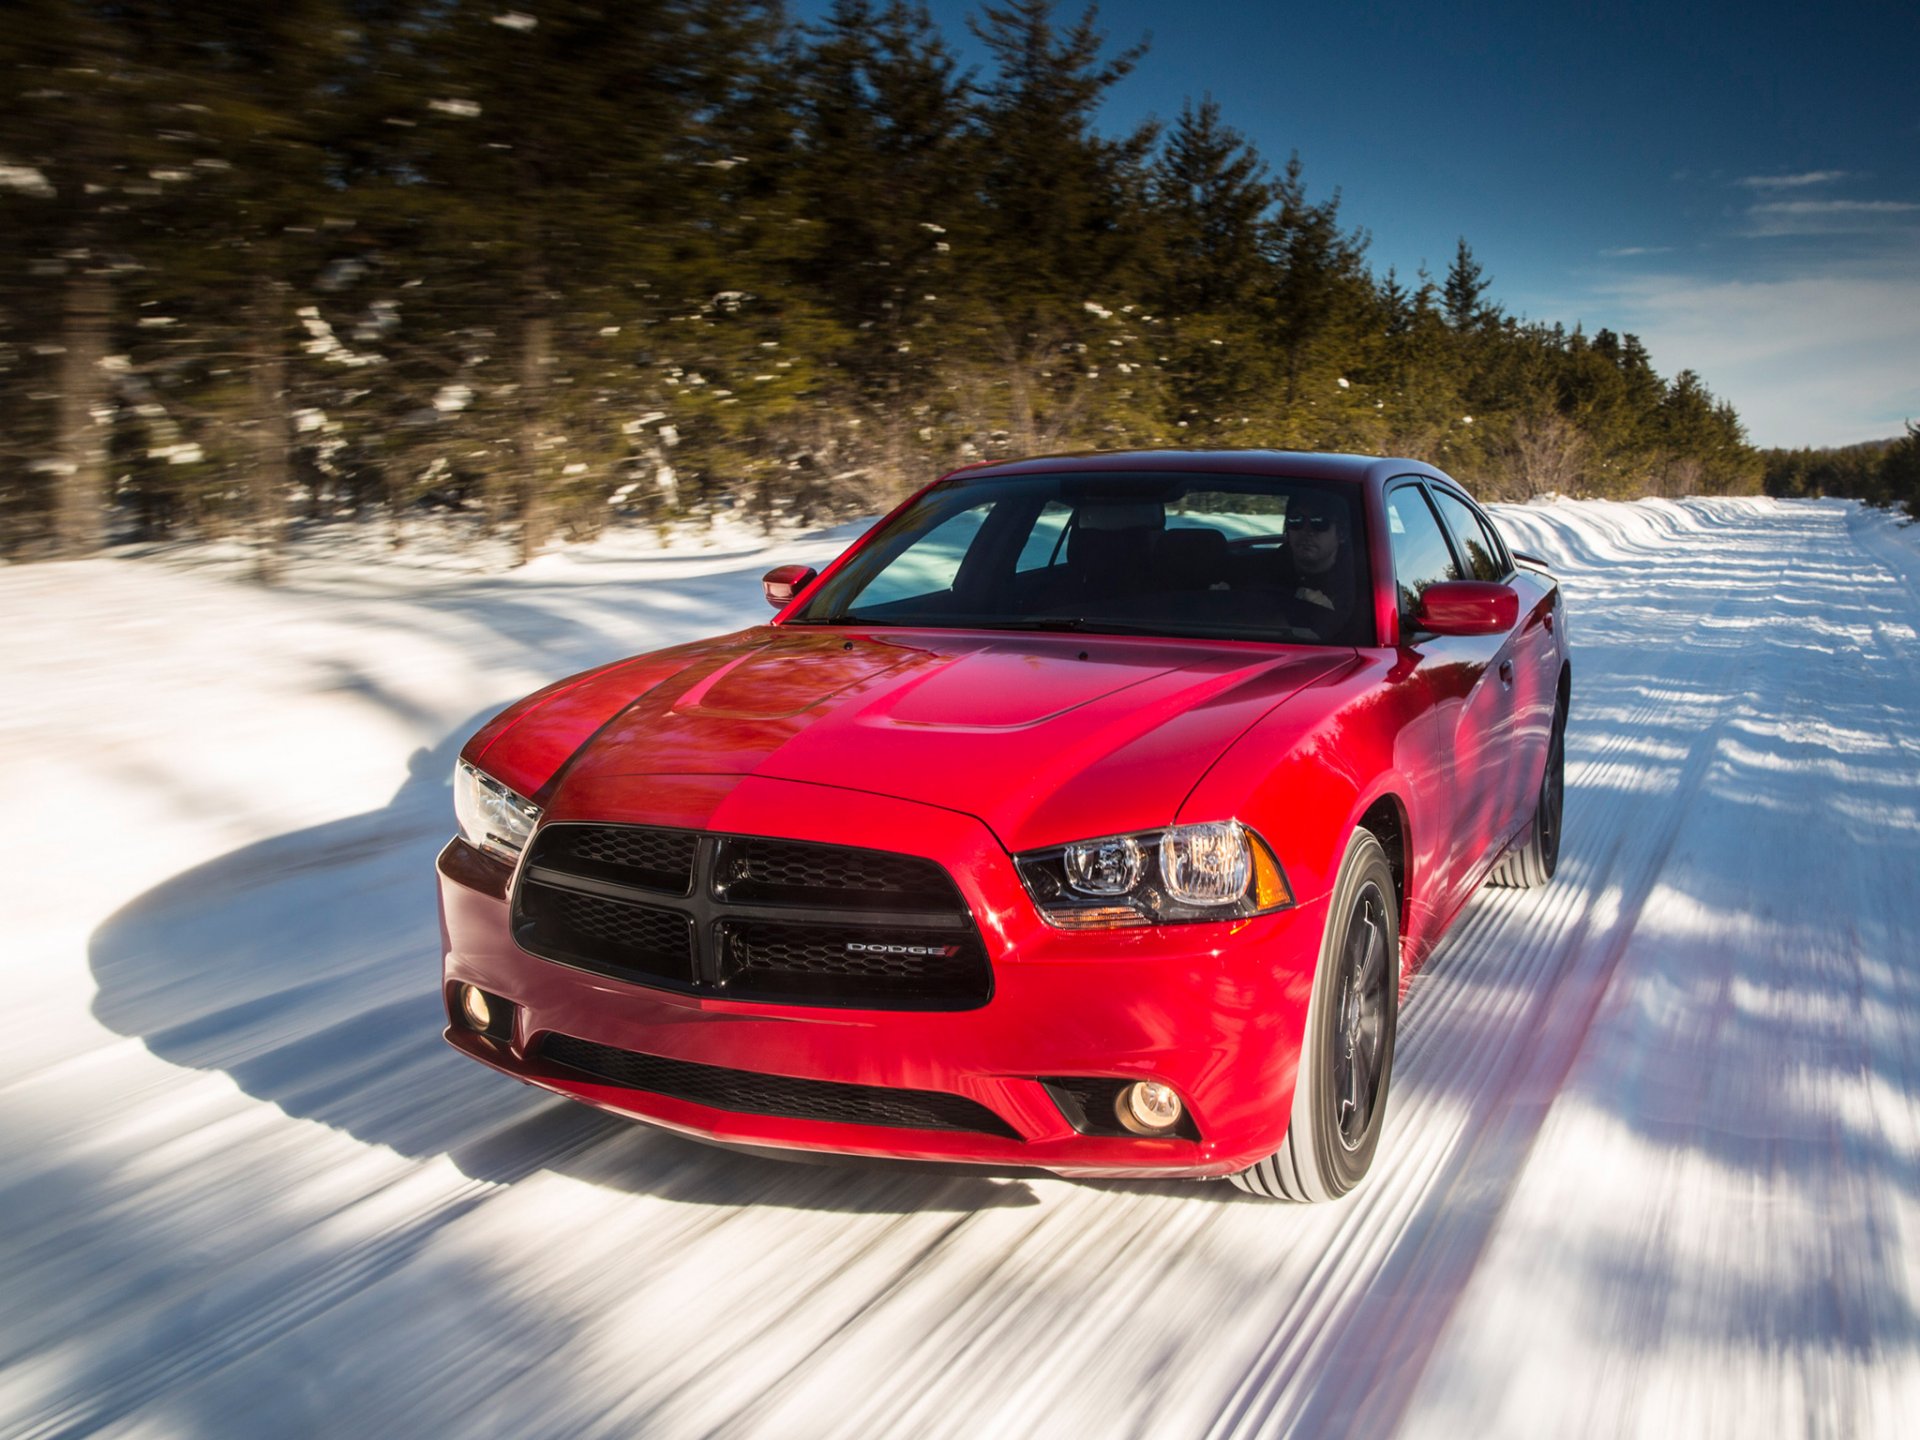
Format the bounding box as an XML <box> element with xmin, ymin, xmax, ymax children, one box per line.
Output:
<box><xmin>1428</xmin><ymin>484</ymin><xmax>1557</xmax><ymax>841</ymax></box>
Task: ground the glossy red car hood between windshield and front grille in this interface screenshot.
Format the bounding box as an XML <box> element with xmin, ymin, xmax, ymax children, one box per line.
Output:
<box><xmin>549</xmin><ymin>626</ymin><xmax>1356</xmax><ymax>849</ymax></box>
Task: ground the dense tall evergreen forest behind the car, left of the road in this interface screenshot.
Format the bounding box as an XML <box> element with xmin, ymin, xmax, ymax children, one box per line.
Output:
<box><xmin>0</xmin><ymin>0</ymin><xmax>1781</xmax><ymax>578</ymax></box>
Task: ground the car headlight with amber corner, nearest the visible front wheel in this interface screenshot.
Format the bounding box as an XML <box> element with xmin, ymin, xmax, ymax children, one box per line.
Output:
<box><xmin>1014</xmin><ymin>820</ymin><xmax>1294</xmax><ymax>929</ymax></box>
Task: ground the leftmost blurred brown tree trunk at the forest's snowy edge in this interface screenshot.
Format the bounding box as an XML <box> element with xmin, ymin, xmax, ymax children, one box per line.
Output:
<box><xmin>54</xmin><ymin>250</ymin><xmax>113</xmax><ymax>555</ymax></box>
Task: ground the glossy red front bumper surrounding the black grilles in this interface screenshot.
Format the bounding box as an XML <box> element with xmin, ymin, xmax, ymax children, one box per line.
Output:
<box><xmin>438</xmin><ymin>778</ymin><xmax>1325</xmax><ymax>1177</ymax></box>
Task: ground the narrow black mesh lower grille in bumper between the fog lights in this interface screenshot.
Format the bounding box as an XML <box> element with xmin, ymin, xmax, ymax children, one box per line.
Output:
<box><xmin>540</xmin><ymin>1035</ymin><xmax>1020</xmax><ymax>1140</ymax></box>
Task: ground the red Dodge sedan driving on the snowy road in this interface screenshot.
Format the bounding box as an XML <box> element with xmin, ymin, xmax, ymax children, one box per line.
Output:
<box><xmin>440</xmin><ymin>451</ymin><xmax>1571</xmax><ymax>1200</ymax></box>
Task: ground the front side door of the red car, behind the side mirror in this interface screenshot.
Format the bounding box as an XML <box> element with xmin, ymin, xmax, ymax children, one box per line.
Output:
<box><xmin>1386</xmin><ymin>480</ymin><xmax>1511</xmax><ymax>920</ymax></box>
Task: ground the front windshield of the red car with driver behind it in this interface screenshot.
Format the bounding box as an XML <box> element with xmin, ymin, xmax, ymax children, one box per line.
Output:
<box><xmin>789</xmin><ymin>474</ymin><xmax>1373</xmax><ymax>645</ymax></box>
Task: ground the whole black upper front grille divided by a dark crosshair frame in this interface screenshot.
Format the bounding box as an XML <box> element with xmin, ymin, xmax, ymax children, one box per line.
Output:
<box><xmin>513</xmin><ymin>822</ymin><xmax>993</xmax><ymax>1010</ymax></box>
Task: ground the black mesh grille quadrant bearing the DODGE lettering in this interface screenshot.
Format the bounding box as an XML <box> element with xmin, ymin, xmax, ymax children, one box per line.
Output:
<box><xmin>720</xmin><ymin>920</ymin><xmax>989</xmax><ymax>1002</ymax></box>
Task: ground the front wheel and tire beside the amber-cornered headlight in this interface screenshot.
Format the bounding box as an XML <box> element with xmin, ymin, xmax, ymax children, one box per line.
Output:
<box><xmin>1229</xmin><ymin>829</ymin><xmax>1400</xmax><ymax>1202</ymax></box>
